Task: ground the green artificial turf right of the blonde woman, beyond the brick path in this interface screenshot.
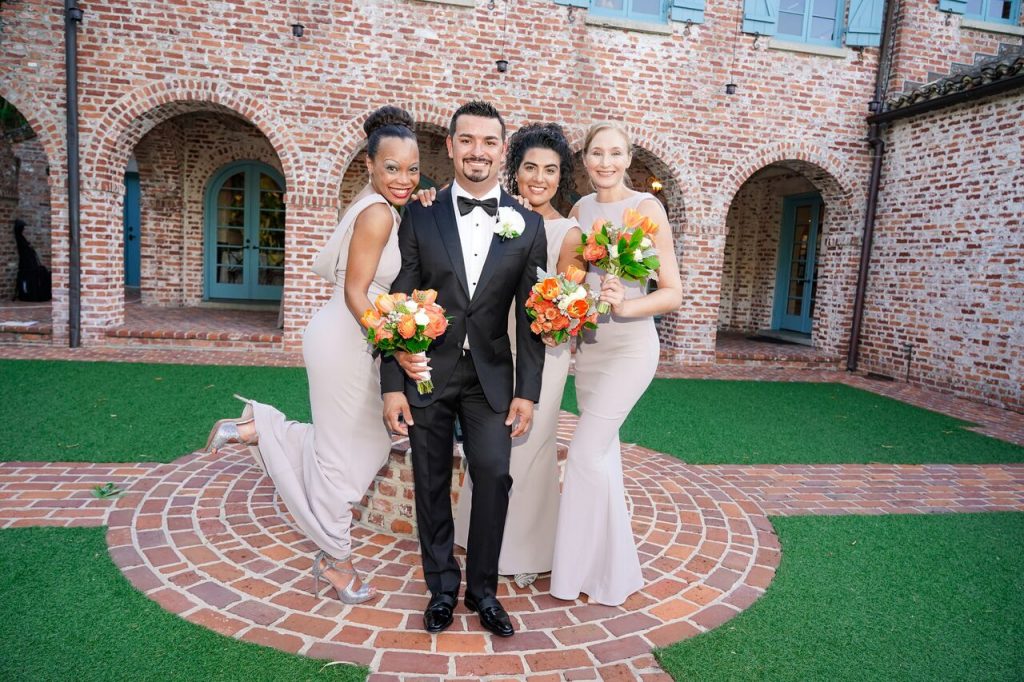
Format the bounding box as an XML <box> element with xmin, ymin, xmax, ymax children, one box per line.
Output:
<box><xmin>562</xmin><ymin>377</ymin><xmax>1024</xmax><ymax>464</ymax></box>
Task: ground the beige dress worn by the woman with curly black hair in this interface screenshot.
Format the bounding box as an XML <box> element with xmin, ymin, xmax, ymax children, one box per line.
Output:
<box><xmin>455</xmin><ymin>218</ymin><xmax>580</xmax><ymax>576</ymax></box>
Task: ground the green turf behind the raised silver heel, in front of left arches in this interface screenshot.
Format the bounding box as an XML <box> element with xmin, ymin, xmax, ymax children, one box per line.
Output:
<box><xmin>0</xmin><ymin>360</ymin><xmax>309</xmax><ymax>462</ymax></box>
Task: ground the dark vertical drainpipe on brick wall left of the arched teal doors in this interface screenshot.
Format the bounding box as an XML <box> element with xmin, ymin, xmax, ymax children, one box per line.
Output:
<box><xmin>65</xmin><ymin>0</ymin><xmax>83</xmax><ymax>348</ymax></box>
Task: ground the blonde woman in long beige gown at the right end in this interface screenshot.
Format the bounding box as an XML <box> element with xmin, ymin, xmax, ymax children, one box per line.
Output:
<box><xmin>551</xmin><ymin>124</ymin><xmax>682</xmax><ymax>606</ymax></box>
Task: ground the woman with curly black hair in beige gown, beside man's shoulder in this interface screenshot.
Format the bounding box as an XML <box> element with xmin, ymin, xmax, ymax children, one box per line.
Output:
<box><xmin>455</xmin><ymin>124</ymin><xmax>587</xmax><ymax>587</ymax></box>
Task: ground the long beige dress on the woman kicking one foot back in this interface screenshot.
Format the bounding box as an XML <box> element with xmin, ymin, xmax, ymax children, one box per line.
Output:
<box><xmin>243</xmin><ymin>194</ymin><xmax>401</xmax><ymax>559</ymax></box>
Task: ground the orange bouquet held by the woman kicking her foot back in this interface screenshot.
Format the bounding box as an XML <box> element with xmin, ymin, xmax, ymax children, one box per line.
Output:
<box><xmin>359</xmin><ymin>289</ymin><xmax>449</xmax><ymax>395</ymax></box>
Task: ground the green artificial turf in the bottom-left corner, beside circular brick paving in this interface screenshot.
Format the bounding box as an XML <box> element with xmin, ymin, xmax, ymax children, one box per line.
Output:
<box><xmin>0</xmin><ymin>528</ymin><xmax>367</xmax><ymax>682</ymax></box>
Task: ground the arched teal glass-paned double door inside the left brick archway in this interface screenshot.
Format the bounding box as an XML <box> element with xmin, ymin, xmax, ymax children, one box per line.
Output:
<box><xmin>206</xmin><ymin>162</ymin><xmax>285</xmax><ymax>300</ymax></box>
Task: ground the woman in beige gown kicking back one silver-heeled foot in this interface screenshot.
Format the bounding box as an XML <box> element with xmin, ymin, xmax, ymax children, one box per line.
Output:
<box><xmin>201</xmin><ymin>106</ymin><xmax>420</xmax><ymax>603</ymax></box>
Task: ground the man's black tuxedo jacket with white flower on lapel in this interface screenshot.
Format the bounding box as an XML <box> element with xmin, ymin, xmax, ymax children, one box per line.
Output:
<box><xmin>381</xmin><ymin>187</ymin><xmax>548</xmax><ymax>412</ymax></box>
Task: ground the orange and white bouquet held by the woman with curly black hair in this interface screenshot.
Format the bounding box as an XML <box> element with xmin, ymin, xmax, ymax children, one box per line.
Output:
<box><xmin>526</xmin><ymin>265</ymin><xmax>597</xmax><ymax>345</ymax></box>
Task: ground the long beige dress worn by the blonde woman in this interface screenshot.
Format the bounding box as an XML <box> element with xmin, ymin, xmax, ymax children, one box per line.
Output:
<box><xmin>551</xmin><ymin>189</ymin><xmax>659</xmax><ymax>606</ymax></box>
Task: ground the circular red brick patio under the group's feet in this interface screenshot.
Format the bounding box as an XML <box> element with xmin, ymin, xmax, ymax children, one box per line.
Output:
<box><xmin>108</xmin><ymin>415</ymin><xmax>779</xmax><ymax>680</ymax></box>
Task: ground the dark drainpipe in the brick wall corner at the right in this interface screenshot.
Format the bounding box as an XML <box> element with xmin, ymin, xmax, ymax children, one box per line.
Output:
<box><xmin>846</xmin><ymin>0</ymin><xmax>899</xmax><ymax>372</ymax></box>
